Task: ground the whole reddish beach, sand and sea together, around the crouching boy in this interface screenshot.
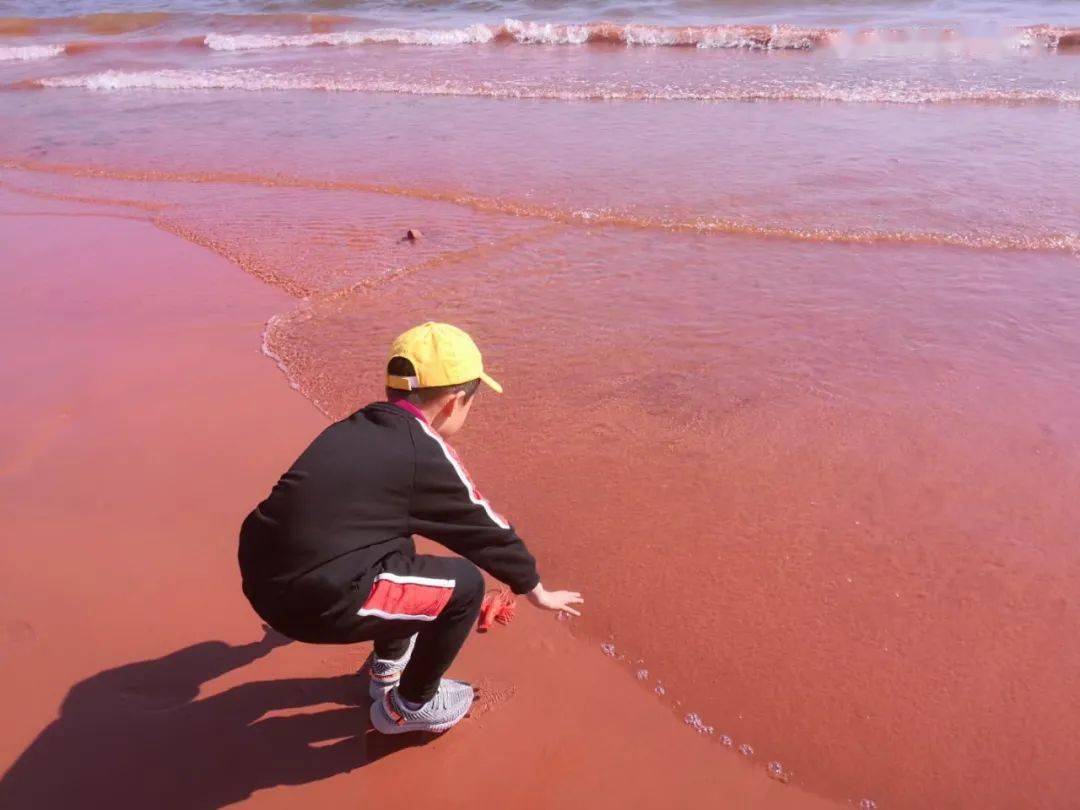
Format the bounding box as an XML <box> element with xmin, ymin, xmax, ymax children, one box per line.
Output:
<box><xmin>0</xmin><ymin>0</ymin><xmax>1080</xmax><ymax>810</ymax></box>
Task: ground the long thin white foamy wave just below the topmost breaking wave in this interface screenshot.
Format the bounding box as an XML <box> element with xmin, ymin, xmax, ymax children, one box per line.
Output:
<box><xmin>31</xmin><ymin>69</ymin><xmax>1080</xmax><ymax>105</ymax></box>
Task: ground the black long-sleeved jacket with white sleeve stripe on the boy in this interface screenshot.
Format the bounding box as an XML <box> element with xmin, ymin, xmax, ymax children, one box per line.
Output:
<box><xmin>240</xmin><ymin>403</ymin><xmax>540</xmax><ymax>616</ymax></box>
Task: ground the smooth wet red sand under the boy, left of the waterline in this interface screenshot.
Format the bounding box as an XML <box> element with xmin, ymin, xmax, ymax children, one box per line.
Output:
<box><xmin>0</xmin><ymin>197</ymin><xmax>828</xmax><ymax>809</ymax></box>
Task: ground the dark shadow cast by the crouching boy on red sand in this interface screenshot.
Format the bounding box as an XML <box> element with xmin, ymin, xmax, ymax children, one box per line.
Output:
<box><xmin>0</xmin><ymin>632</ymin><xmax>433</xmax><ymax>810</ymax></box>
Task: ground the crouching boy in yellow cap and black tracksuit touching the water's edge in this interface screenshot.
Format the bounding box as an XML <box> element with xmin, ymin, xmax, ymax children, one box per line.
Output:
<box><xmin>240</xmin><ymin>323</ymin><xmax>582</xmax><ymax>734</ymax></box>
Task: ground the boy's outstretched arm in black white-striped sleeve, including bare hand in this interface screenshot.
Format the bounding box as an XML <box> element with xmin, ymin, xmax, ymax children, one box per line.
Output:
<box><xmin>409</xmin><ymin>423</ymin><xmax>582</xmax><ymax>616</ymax></box>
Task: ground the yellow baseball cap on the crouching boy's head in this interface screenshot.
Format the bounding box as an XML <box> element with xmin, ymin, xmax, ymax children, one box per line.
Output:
<box><xmin>387</xmin><ymin>321</ymin><xmax>502</xmax><ymax>394</ymax></box>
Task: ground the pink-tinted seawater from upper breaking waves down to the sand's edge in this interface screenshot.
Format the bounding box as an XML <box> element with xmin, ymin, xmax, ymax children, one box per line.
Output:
<box><xmin>0</xmin><ymin>7</ymin><xmax>1080</xmax><ymax>808</ymax></box>
